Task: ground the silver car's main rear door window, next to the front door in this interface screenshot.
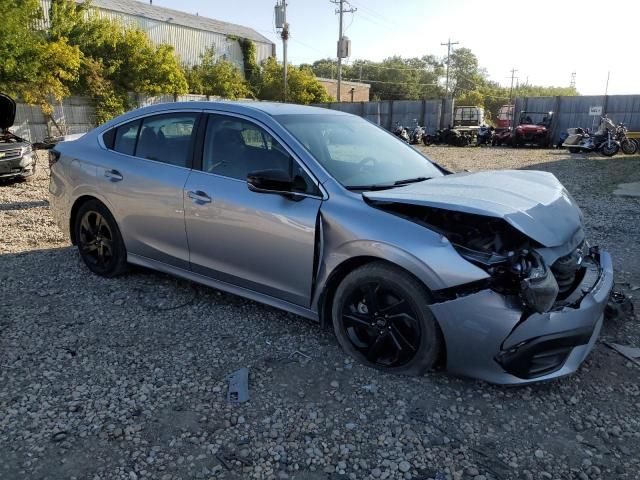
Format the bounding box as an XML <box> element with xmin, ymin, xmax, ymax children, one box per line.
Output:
<box><xmin>135</xmin><ymin>113</ymin><xmax>198</xmax><ymax>167</ymax></box>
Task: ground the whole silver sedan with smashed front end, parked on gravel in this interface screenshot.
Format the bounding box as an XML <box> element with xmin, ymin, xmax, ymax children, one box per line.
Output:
<box><xmin>49</xmin><ymin>102</ymin><xmax>613</xmax><ymax>384</ymax></box>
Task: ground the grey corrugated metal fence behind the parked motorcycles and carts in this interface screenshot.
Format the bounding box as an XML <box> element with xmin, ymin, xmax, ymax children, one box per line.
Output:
<box><xmin>316</xmin><ymin>95</ymin><xmax>640</xmax><ymax>141</ymax></box>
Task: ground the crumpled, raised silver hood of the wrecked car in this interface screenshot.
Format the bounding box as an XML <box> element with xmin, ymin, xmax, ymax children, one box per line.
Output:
<box><xmin>363</xmin><ymin>170</ymin><xmax>582</xmax><ymax>247</ymax></box>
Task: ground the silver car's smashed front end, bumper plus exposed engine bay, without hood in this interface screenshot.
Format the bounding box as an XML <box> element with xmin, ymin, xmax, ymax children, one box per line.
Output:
<box><xmin>372</xmin><ymin>202</ymin><xmax>613</xmax><ymax>384</ymax></box>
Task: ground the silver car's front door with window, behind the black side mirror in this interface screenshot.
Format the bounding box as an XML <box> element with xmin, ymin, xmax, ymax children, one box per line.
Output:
<box><xmin>185</xmin><ymin>114</ymin><xmax>322</xmax><ymax>307</ymax></box>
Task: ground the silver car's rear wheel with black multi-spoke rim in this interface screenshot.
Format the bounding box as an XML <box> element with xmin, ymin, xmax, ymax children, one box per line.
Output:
<box><xmin>74</xmin><ymin>200</ymin><xmax>127</xmax><ymax>277</ymax></box>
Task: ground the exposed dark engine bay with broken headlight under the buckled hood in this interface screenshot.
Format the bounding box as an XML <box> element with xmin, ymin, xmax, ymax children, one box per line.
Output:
<box><xmin>372</xmin><ymin>202</ymin><xmax>585</xmax><ymax>313</ymax></box>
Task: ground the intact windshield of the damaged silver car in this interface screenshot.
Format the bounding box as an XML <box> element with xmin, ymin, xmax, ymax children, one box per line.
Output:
<box><xmin>278</xmin><ymin>114</ymin><xmax>443</xmax><ymax>190</ymax></box>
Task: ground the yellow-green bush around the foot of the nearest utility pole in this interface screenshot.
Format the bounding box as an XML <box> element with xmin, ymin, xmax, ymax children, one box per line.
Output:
<box><xmin>257</xmin><ymin>58</ymin><xmax>331</xmax><ymax>105</ymax></box>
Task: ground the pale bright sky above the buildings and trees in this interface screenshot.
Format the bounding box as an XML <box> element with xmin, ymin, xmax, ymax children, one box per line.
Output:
<box><xmin>145</xmin><ymin>0</ymin><xmax>640</xmax><ymax>95</ymax></box>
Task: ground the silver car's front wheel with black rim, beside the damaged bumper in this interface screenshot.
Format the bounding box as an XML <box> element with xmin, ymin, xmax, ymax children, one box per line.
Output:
<box><xmin>331</xmin><ymin>262</ymin><xmax>443</xmax><ymax>375</ymax></box>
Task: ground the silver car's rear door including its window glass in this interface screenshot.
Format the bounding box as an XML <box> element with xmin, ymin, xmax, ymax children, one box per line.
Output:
<box><xmin>97</xmin><ymin>111</ymin><xmax>200</xmax><ymax>269</ymax></box>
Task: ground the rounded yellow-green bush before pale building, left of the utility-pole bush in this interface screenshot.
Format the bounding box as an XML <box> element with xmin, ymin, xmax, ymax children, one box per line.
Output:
<box><xmin>187</xmin><ymin>48</ymin><xmax>253</xmax><ymax>100</ymax></box>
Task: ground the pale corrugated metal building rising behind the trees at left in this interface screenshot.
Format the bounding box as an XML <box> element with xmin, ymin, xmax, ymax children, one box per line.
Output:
<box><xmin>40</xmin><ymin>0</ymin><xmax>276</xmax><ymax>72</ymax></box>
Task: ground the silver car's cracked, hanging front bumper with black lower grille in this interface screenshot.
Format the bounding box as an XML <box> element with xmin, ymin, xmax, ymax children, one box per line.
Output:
<box><xmin>430</xmin><ymin>252</ymin><xmax>613</xmax><ymax>385</ymax></box>
